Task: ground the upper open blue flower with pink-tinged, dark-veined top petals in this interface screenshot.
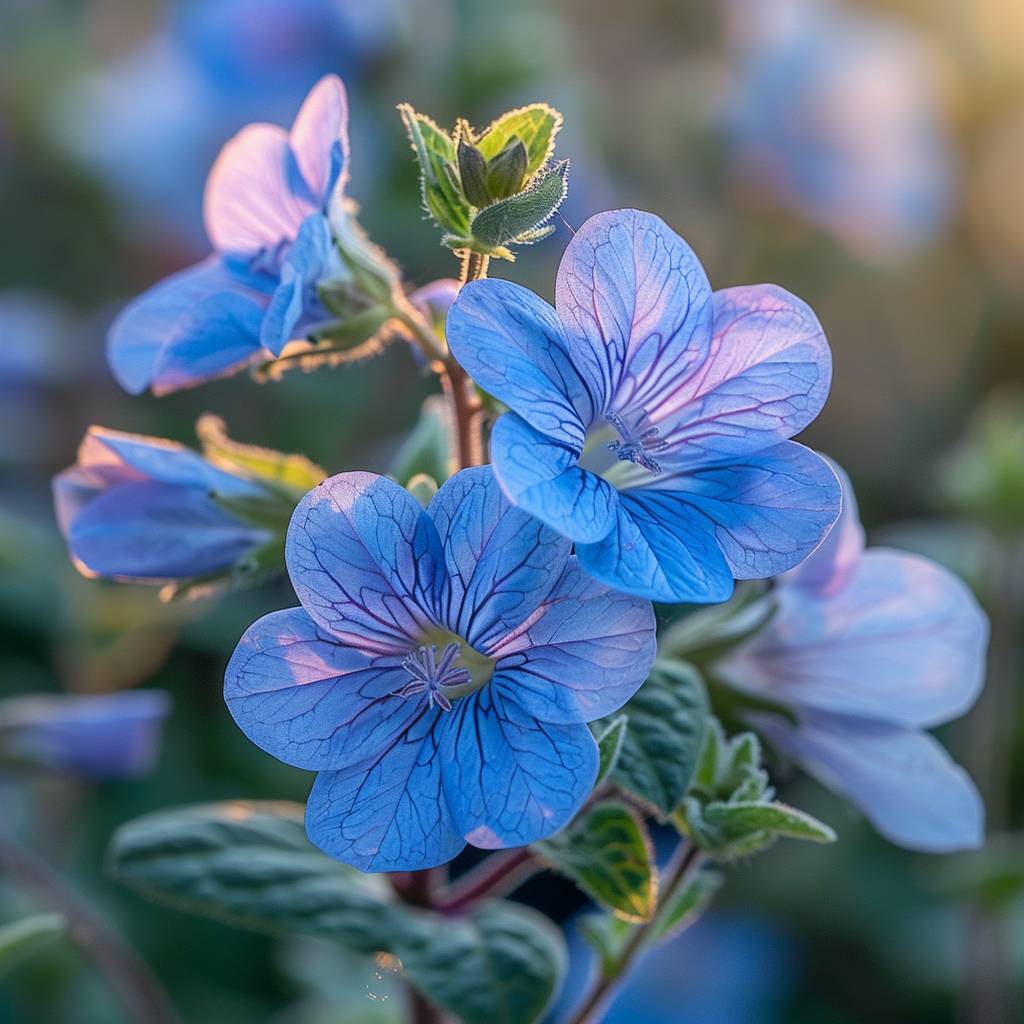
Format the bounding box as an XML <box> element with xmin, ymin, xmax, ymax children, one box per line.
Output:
<box><xmin>447</xmin><ymin>210</ymin><xmax>840</xmax><ymax>601</ymax></box>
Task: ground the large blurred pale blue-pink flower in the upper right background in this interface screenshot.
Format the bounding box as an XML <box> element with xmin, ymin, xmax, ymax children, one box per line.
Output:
<box><xmin>723</xmin><ymin>0</ymin><xmax>954</xmax><ymax>256</ymax></box>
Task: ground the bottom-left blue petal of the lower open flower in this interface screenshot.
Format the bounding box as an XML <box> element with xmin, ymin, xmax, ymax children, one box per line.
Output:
<box><xmin>306</xmin><ymin>705</ymin><xmax>466</xmax><ymax>871</ymax></box>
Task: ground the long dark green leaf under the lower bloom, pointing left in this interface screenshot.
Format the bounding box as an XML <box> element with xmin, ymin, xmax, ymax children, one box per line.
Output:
<box><xmin>108</xmin><ymin>801</ymin><xmax>398</xmax><ymax>952</ymax></box>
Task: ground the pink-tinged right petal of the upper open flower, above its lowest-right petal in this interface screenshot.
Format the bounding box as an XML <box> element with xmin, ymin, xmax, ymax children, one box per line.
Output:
<box><xmin>647</xmin><ymin>285</ymin><xmax>831</xmax><ymax>456</ymax></box>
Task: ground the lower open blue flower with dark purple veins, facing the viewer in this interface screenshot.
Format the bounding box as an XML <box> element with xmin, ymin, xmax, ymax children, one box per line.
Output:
<box><xmin>224</xmin><ymin>467</ymin><xmax>655</xmax><ymax>871</ymax></box>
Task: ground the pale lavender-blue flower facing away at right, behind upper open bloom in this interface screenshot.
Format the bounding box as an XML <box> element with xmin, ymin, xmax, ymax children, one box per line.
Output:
<box><xmin>715</xmin><ymin>467</ymin><xmax>988</xmax><ymax>853</ymax></box>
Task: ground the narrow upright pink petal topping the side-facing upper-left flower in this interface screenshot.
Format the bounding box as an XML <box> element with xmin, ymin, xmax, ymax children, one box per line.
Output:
<box><xmin>291</xmin><ymin>75</ymin><xmax>348</xmax><ymax>208</ymax></box>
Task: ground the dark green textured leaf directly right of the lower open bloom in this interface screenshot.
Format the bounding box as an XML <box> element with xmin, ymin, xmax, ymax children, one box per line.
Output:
<box><xmin>612</xmin><ymin>662</ymin><xmax>708</xmax><ymax>817</ymax></box>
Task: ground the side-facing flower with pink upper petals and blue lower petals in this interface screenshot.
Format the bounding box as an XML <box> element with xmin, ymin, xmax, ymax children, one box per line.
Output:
<box><xmin>108</xmin><ymin>75</ymin><xmax>348</xmax><ymax>394</ymax></box>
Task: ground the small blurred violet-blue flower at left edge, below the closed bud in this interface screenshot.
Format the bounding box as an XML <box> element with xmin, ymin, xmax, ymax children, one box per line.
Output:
<box><xmin>0</xmin><ymin>690</ymin><xmax>171</xmax><ymax>779</ymax></box>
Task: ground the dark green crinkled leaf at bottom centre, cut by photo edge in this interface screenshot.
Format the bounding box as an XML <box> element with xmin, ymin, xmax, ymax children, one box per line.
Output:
<box><xmin>393</xmin><ymin>901</ymin><xmax>565</xmax><ymax>1024</ymax></box>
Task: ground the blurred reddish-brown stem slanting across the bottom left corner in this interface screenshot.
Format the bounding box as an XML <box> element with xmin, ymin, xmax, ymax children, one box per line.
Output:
<box><xmin>0</xmin><ymin>839</ymin><xmax>177</xmax><ymax>1024</ymax></box>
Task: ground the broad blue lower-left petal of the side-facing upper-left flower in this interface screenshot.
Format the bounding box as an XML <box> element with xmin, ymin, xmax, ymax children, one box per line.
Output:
<box><xmin>106</xmin><ymin>257</ymin><xmax>269</xmax><ymax>394</ymax></box>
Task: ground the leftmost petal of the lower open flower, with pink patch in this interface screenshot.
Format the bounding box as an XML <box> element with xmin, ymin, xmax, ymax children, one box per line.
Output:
<box><xmin>224</xmin><ymin>608</ymin><xmax>421</xmax><ymax>771</ymax></box>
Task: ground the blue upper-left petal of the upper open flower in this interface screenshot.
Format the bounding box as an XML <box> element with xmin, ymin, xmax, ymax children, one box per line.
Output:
<box><xmin>445</xmin><ymin>279</ymin><xmax>599</xmax><ymax>453</ymax></box>
